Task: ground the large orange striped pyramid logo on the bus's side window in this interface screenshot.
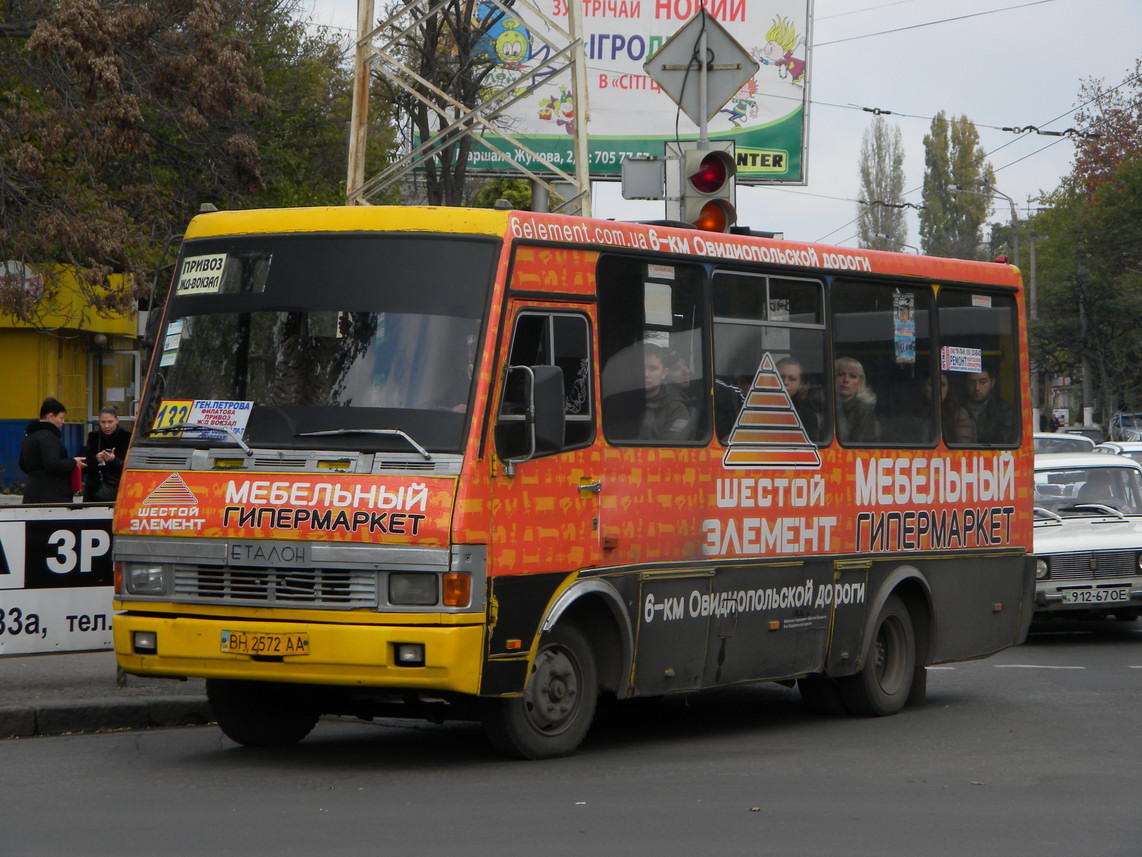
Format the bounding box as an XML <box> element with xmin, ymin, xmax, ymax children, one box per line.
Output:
<box><xmin>722</xmin><ymin>352</ymin><xmax>821</xmax><ymax>467</ymax></box>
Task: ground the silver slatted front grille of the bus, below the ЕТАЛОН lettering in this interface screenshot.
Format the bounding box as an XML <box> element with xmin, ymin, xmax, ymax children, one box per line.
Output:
<box><xmin>175</xmin><ymin>566</ymin><xmax>377</xmax><ymax>609</ymax></box>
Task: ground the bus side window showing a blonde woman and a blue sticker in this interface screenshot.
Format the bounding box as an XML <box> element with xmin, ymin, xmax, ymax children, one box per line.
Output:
<box><xmin>833</xmin><ymin>279</ymin><xmax>939</xmax><ymax>447</ymax></box>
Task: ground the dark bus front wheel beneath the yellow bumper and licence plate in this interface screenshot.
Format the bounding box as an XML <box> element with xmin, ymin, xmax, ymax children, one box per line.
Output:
<box><xmin>207</xmin><ymin>679</ymin><xmax>320</xmax><ymax>747</ymax></box>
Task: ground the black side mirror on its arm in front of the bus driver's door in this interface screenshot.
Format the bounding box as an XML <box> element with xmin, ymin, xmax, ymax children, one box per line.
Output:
<box><xmin>496</xmin><ymin>366</ymin><xmax>564</xmax><ymax>475</ymax></box>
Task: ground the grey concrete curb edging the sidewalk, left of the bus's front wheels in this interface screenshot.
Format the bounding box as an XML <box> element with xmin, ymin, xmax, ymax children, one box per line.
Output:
<box><xmin>0</xmin><ymin>696</ymin><xmax>214</xmax><ymax>738</ymax></box>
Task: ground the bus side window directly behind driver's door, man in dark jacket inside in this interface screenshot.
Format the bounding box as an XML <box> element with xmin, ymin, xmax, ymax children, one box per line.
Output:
<box><xmin>596</xmin><ymin>256</ymin><xmax>711</xmax><ymax>446</ymax></box>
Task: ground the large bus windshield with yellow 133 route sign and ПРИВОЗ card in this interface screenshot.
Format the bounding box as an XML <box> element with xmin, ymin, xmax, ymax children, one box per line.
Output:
<box><xmin>139</xmin><ymin>234</ymin><xmax>498</xmax><ymax>452</ymax></box>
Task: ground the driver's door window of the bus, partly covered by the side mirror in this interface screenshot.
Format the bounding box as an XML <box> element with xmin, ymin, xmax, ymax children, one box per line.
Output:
<box><xmin>496</xmin><ymin>311</ymin><xmax>595</xmax><ymax>450</ymax></box>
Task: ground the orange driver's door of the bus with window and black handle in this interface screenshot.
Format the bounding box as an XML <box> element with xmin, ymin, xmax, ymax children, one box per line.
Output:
<box><xmin>489</xmin><ymin>303</ymin><xmax>602</xmax><ymax>580</ymax></box>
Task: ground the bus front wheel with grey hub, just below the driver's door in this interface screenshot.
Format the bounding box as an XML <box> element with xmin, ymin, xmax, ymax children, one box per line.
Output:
<box><xmin>483</xmin><ymin>624</ymin><xmax>598</xmax><ymax>759</ymax></box>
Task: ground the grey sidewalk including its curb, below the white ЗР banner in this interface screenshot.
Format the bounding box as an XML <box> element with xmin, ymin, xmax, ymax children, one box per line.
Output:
<box><xmin>0</xmin><ymin>651</ymin><xmax>211</xmax><ymax>738</ymax></box>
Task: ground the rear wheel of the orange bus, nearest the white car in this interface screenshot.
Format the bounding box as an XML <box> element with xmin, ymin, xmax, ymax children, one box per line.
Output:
<box><xmin>837</xmin><ymin>595</ymin><xmax>916</xmax><ymax>716</ymax></box>
